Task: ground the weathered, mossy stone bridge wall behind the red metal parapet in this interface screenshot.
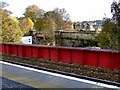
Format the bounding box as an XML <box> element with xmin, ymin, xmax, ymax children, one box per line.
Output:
<box><xmin>55</xmin><ymin>30</ymin><xmax>98</xmax><ymax>47</ymax></box>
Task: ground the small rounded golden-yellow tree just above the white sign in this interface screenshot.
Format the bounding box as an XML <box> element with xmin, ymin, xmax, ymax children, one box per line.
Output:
<box><xmin>19</xmin><ymin>18</ymin><xmax>34</xmax><ymax>35</ymax></box>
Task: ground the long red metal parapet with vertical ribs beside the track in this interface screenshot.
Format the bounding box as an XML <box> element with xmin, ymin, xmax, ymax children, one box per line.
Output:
<box><xmin>0</xmin><ymin>43</ymin><xmax>120</xmax><ymax>70</ymax></box>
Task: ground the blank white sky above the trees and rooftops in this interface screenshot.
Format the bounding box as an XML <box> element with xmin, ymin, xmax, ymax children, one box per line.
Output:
<box><xmin>1</xmin><ymin>0</ymin><xmax>113</xmax><ymax>21</ymax></box>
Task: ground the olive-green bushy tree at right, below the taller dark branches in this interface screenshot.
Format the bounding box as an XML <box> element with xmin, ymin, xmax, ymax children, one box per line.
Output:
<box><xmin>97</xmin><ymin>19</ymin><xmax>118</xmax><ymax>50</ymax></box>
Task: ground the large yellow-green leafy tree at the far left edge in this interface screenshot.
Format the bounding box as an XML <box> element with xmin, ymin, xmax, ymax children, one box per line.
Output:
<box><xmin>0</xmin><ymin>3</ymin><xmax>22</xmax><ymax>43</ymax></box>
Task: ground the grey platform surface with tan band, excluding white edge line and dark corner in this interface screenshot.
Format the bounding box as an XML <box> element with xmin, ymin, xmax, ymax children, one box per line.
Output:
<box><xmin>0</xmin><ymin>63</ymin><xmax>109</xmax><ymax>88</ymax></box>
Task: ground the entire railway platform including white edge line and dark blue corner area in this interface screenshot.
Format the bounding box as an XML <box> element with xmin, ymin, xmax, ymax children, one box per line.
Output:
<box><xmin>0</xmin><ymin>61</ymin><xmax>120</xmax><ymax>89</ymax></box>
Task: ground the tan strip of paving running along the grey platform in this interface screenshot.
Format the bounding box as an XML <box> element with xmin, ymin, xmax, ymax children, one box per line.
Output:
<box><xmin>2</xmin><ymin>71</ymin><xmax>60</xmax><ymax>88</ymax></box>
